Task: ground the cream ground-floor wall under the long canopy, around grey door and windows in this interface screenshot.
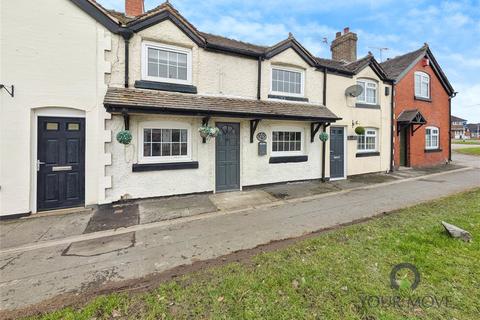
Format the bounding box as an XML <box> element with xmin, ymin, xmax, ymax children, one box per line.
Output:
<box><xmin>107</xmin><ymin>115</ymin><xmax>321</xmax><ymax>201</ymax></box>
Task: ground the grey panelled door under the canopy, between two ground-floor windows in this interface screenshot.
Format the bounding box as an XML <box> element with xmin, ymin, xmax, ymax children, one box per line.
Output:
<box><xmin>215</xmin><ymin>122</ymin><xmax>240</xmax><ymax>191</ymax></box>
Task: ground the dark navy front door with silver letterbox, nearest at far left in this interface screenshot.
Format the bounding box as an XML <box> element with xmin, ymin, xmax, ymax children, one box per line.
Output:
<box><xmin>37</xmin><ymin>117</ymin><xmax>85</xmax><ymax>211</ymax></box>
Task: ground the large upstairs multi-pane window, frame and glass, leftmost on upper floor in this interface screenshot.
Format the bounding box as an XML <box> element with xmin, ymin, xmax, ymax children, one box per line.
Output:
<box><xmin>142</xmin><ymin>42</ymin><xmax>192</xmax><ymax>84</ymax></box>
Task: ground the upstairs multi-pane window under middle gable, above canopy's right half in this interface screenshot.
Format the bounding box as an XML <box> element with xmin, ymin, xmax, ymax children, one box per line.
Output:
<box><xmin>271</xmin><ymin>67</ymin><xmax>304</xmax><ymax>97</ymax></box>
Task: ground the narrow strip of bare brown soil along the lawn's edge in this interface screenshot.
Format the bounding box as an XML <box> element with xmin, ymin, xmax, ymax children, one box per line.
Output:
<box><xmin>0</xmin><ymin>212</ymin><xmax>390</xmax><ymax>319</ymax></box>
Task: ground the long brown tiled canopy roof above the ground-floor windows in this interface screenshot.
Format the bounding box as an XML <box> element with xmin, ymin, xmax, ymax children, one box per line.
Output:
<box><xmin>104</xmin><ymin>87</ymin><xmax>340</xmax><ymax>121</ymax></box>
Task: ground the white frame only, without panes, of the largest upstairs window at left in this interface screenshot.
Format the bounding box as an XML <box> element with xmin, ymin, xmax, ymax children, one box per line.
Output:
<box><xmin>142</xmin><ymin>41</ymin><xmax>192</xmax><ymax>85</ymax></box>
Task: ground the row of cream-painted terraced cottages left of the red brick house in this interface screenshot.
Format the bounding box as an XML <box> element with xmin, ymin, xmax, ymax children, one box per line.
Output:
<box><xmin>0</xmin><ymin>0</ymin><xmax>400</xmax><ymax>215</ymax></box>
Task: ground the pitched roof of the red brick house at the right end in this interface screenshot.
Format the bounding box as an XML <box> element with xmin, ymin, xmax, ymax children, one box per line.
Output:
<box><xmin>380</xmin><ymin>43</ymin><xmax>455</xmax><ymax>96</ymax></box>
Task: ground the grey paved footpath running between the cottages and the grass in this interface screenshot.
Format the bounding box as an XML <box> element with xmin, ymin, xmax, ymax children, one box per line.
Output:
<box><xmin>0</xmin><ymin>164</ymin><xmax>480</xmax><ymax>310</ymax></box>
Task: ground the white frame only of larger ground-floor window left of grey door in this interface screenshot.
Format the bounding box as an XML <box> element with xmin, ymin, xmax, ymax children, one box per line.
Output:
<box><xmin>138</xmin><ymin>121</ymin><xmax>192</xmax><ymax>164</ymax></box>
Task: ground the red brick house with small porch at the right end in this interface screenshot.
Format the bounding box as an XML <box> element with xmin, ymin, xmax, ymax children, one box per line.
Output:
<box><xmin>381</xmin><ymin>44</ymin><xmax>456</xmax><ymax>168</ymax></box>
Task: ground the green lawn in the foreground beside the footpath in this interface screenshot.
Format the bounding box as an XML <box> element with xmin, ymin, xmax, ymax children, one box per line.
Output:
<box><xmin>27</xmin><ymin>189</ymin><xmax>480</xmax><ymax>320</ymax></box>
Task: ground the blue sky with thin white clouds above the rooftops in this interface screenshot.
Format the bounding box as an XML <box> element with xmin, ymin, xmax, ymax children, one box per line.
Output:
<box><xmin>97</xmin><ymin>0</ymin><xmax>480</xmax><ymax>123</ymax></box>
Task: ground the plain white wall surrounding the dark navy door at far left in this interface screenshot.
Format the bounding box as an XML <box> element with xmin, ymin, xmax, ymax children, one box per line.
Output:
<box><xmin>0</xmin><ymin>0</ymin><xmax>111</xmax><ymax>215</ymax></box>
